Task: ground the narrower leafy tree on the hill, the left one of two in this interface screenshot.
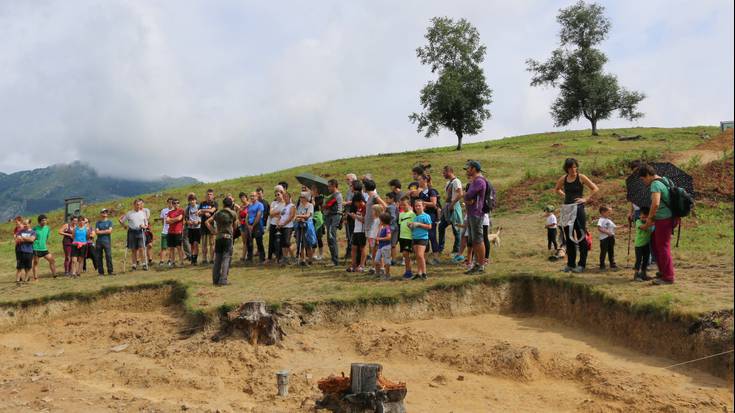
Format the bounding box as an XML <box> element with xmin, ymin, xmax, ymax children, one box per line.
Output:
<box><xmin>408</xmin><ymin>17</ymin><xmax>492</xmax><ymax>151</ymax></box>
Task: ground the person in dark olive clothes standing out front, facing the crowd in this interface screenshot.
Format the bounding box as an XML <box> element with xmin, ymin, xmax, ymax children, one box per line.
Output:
<box><xmin>205</xmin><ymin>198</ymin><xmax>237</xmax><ymax>286</ymax></box>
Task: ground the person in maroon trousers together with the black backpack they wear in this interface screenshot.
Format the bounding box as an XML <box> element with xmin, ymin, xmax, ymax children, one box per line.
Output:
<box><xmin>638</xmin><ymin>165</ymin><xmax>692</xmax><ymax>285</ymax></box>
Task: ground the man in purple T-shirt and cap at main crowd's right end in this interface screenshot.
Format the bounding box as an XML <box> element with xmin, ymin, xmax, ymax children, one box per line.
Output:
<box><xmin>464</xmin><ymin>161</ymin><xmax>487</xmax><ymax>274</ymax></box>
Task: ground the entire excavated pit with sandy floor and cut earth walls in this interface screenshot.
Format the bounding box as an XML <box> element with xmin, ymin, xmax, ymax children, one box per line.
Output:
<box><xmin>0</xmin><ymin>277</ymin><xmax>733</xmax><ymax>412</ymax></box>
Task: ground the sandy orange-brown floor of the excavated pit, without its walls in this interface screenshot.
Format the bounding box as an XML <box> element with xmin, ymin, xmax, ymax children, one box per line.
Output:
<box><xmin>0</xmin><ymin>300</ymin><xmax>733</xmax><ymax>412</ymax></box>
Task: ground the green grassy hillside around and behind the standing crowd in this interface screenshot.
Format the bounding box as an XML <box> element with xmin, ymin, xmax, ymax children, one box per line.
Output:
<box><xmin>0</xmin><ymin>127</ymin><xmax>733</xmax><ymax>318</ymax></box>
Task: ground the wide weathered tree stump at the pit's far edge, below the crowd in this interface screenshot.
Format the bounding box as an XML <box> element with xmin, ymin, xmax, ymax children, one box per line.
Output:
<box><xmin>212</xmin><ymin>301</ymin><xmax>286</xmax><ymax>345</ymax></box>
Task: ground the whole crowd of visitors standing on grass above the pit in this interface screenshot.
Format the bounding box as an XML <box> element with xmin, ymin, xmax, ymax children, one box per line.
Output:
<box><xmin>14</xmin><ymin>158</ymin><xmax>674</xmax><ymax>285</ymax></box>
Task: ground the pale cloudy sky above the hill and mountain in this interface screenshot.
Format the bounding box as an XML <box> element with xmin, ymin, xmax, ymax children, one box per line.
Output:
<box><xmin>0</xmin><ymin>0</ymin><xmax>735</xmax><ymax>181</ymax></box>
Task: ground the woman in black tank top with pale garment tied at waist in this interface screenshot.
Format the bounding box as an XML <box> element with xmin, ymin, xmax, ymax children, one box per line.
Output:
<box><xmin>555</xmin><ymin>158</ymin><xmax>599</xmax><ymax>273</ymax></box>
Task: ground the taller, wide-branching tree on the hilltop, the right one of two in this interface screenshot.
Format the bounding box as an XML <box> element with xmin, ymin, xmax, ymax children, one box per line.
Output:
<box><xmin>526</xmin><ymin>0</ymin><xmax>646</xmax><ymax>136</ymax></box>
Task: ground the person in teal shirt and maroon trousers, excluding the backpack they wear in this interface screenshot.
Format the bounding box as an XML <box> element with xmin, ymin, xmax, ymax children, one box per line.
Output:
<box><xmin>638</xmin><ymin>164</ymin><xmax>678</xmax><ymax>285</ymax></box>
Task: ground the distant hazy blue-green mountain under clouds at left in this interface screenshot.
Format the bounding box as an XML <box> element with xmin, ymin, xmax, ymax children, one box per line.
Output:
<box><xmin>0</xmin><ymin>161</ymin><xmax>199</xmax><ymax>222</ymax></box>
